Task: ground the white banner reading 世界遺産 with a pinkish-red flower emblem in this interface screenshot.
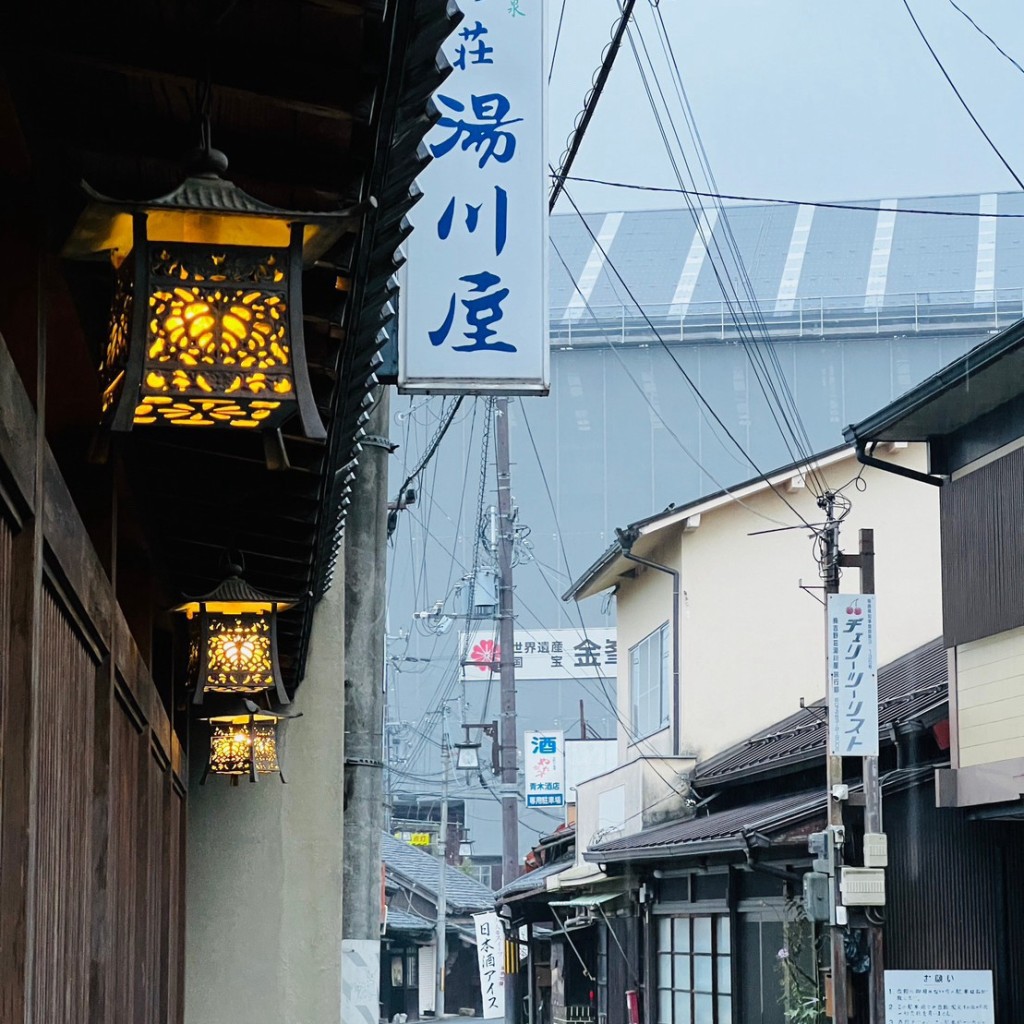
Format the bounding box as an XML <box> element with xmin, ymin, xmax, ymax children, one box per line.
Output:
<box><xmin>459</xmin><ymin>627</ymin><xmax>618</xmax><ymax>683</ymax></box>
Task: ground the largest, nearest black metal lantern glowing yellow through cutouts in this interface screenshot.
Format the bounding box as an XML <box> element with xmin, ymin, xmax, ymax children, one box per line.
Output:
<box><xmin>63</xmin><ymin>151</ymin><xmax>351</xmax><ymax>440</ymax></box>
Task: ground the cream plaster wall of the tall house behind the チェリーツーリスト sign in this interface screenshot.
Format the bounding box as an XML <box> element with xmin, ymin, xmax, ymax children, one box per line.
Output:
<box><xmin>602</xmin><ymin>445</ymin><xmax>942</xmax><ymax>765</ymax></box>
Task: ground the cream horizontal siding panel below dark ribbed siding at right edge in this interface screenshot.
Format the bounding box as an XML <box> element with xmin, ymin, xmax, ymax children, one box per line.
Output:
<box><xmin>956</xmin><ymin>629</ymin><xmax>1024</xmax><ymax>768</ymax></box>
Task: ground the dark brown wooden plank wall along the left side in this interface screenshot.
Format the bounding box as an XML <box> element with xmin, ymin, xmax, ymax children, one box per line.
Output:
<box><xmin>0</xmin><ymin>329</ymin><xmax>186</xmax><ymax>1024</ymax></box>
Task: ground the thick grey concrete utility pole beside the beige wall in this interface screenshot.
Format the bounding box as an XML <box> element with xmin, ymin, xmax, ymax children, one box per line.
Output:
<box><xmin>342</xmin><ymin>387</ymin><xmax>391</xmax><ymax>1024</ymax></box>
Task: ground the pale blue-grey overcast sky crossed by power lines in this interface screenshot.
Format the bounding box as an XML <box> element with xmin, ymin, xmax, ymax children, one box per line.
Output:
<box><xmin>544</xmin><ymin>0</ymin><xmax>1024</xmax><ymax>212</ymax></box>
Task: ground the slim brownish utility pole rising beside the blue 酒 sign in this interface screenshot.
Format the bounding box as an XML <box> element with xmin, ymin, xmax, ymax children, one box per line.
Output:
<box><xmin>495</xmin><ymin>398</ymin><xmax>520</xmax><ymax>1024</ymax></box>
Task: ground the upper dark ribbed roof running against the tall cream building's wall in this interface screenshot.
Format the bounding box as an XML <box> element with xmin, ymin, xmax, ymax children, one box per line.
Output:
<box><xmin>693</xmin><ymin>637</ymin><xmax>948</xmax><ymax>788</ymax></box>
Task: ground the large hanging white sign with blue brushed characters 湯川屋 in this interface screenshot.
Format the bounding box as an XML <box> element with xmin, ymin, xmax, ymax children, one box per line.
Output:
<box><xmin>398</xmin><ymin>0</ymin><xmax>548</xmax><ymax>394</ymax></box>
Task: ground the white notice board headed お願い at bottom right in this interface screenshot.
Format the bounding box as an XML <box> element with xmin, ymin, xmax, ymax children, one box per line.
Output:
<box><xmin>886</xmin><ymin>971</ymin><xmax>995</xmax><ymax>1024</ymax></box>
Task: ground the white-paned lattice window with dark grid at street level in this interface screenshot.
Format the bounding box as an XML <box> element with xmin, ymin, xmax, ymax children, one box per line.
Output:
<box><xmin>657</xmin><ymin>914</ymin><xmax>732</xmax><ymax>1024</ymax></box>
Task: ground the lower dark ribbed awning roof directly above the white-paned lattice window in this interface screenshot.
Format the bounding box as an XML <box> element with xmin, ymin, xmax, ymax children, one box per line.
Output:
<box><xmin>585</xmin><ymin>765</ymin><xmax>936</xmax><ymax>863</ymax></box>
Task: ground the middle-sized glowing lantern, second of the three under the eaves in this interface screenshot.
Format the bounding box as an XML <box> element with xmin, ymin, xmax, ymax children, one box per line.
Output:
<box><xmin>174</xmin><ymin>565</ymin><xmax>295</xmax><ymax>705</ymax></box>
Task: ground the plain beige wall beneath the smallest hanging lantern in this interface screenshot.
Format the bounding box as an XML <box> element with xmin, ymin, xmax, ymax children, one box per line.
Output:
<box><xmin>185</xmin><ymin>571</ymin><xmax>345</xmax><ymax>1024</ymax></box>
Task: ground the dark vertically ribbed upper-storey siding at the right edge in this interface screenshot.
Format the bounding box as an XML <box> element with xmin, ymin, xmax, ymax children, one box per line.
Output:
<box><xmin>939</xmin><ymin>449</ymin><xmax>1024</xmax><ymax>647</ymax></box>
